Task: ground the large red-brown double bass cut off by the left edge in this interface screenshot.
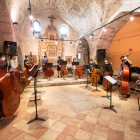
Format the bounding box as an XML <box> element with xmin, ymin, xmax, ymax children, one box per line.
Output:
<box><xmin>0</xmin><ymin>70</ymin><xmax>20</xmax><ymax>117</ymax></box>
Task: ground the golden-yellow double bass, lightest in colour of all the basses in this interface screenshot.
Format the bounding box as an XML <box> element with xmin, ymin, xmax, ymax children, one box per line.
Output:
<box><xmin>90</xmin><ymin>56</ymin><xmax>100</xmax><ymax>84</ymax></box>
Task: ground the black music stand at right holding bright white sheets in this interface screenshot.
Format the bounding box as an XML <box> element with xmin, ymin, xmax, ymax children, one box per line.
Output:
<box><xmin>103</xmin><ymin>76</ymin><xmax>117</xmax><ymax>113</ymax></box>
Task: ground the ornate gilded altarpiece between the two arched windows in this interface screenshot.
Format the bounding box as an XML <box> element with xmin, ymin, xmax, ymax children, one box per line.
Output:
<box><xmin>38</xmin><ymin>25</ymin><xmax>64</xmax><ymax>66</ymax></box>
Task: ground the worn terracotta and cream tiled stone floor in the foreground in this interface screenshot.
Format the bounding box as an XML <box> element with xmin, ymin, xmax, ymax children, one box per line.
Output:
<box><xmin>0</xmin><ymin>84</ymin><xmax>140</xmax><ymax>140</ymax></box>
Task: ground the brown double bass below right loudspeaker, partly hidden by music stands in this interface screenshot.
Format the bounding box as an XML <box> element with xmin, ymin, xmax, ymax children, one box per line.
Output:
<box><xmin>103</xmin><ymin>54</ymin><xmax>113</xmax><ymax>90</ymax></box>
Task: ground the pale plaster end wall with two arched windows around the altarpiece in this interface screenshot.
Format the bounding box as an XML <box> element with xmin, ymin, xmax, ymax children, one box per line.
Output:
<box><xmin>21</xmin><ymin>10</ymin><xmax>77</xmax><ymax>64</ymax></box>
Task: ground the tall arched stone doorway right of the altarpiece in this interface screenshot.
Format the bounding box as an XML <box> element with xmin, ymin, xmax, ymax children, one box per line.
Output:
<box><xmin>77</xmin><ymin>38</ymin><xmax>90</xmax><ymax>65</ymax></box>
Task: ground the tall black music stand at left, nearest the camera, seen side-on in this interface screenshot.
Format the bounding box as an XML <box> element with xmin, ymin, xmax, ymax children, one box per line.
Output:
<box><xmin>27</xmin><ymin>68</ymin><xmax>46</xmax><ymax>124</ymax></box>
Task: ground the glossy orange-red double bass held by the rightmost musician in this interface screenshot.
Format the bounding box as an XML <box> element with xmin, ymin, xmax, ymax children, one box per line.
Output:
<box><xmin>118</xmin><ymin>48</ymin><xmax>133</xmax><ymax>95</ymax></box>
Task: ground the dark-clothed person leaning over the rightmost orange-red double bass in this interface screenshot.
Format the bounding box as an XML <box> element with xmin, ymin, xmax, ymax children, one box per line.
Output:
<box><xmin>118</xmin><ymin>56</ymin><xmax>132</xmax><ymax>98</ymax></box>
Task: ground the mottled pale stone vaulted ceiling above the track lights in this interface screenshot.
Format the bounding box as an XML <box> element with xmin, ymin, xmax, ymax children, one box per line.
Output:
<box><xmin>6</xmin><ymin>0</ymin><xmax>140</xmax><ymax>37</ymax></box>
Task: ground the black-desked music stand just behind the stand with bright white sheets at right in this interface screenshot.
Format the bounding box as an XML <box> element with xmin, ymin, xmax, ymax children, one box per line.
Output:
<box><xmin>101</xmin><ymin>64</ymin><xmax>113</xmax><ymax>100</ymax></box>
